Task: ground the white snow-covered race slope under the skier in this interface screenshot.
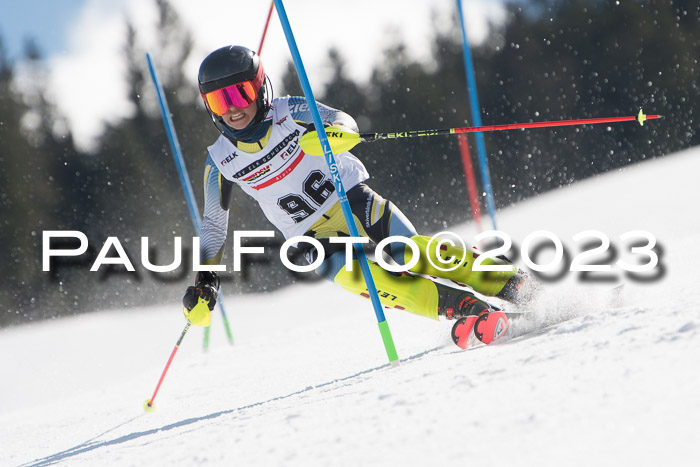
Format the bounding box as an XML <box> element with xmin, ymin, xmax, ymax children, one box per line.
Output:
<box><xmin>0</xmin><ymin>149</ymin><xmax>700</xmax><ymax>466</ymax></box>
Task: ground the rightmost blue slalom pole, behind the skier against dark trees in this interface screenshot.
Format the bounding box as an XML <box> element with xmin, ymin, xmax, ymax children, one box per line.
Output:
<box><xmin>457</xmin><ymin>0</ymin><xmax>498</xmax><ymax>230</ymax></box>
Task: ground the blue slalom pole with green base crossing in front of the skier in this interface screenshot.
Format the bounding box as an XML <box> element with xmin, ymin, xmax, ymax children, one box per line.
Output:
<box><xmin>274</xmin><ymin>0</ymin><xmax>399</xmax><ymax>365</ymax></box>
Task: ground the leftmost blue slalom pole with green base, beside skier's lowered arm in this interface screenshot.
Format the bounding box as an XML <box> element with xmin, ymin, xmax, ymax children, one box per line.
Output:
<box><xmin>146</xmin><ymin>53</ymin><xmax>233</xmax><ymax>349</ymax></box>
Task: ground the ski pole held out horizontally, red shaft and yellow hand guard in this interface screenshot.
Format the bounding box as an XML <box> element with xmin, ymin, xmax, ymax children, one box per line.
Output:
<box><xmin>300</xmin><ymin>110</ymin><xmax>661</xmax><ymax>156</ymax></box>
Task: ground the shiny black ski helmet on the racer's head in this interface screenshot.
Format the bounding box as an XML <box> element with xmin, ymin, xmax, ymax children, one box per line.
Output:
<box><xmin>198</xmin><ymin>45</ymin><xmax>272</xmax><ymax>140</ymax></box>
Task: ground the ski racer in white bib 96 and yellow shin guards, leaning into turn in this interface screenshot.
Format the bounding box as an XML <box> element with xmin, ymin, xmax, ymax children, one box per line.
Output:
<box><xmin>183</xmin><ymin>46</ymin><xmax>531</xmax><ymax>343</ymax></box>
